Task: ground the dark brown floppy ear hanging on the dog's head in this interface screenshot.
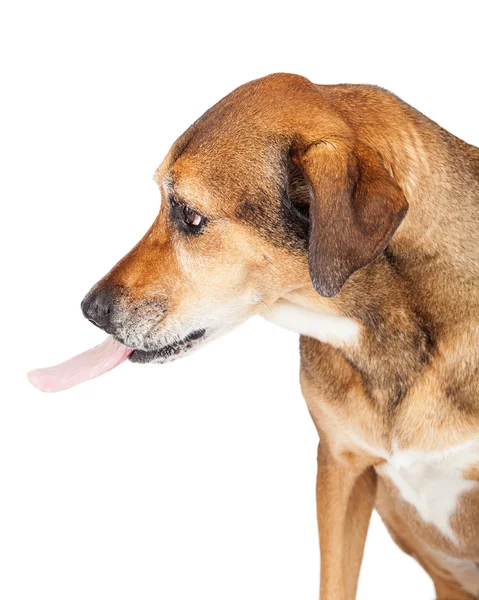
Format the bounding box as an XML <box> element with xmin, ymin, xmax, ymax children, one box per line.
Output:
<box><xmin>293</xmin><ymin>139</ymin><xmax>408</xmax><ymax>297</ymax></box>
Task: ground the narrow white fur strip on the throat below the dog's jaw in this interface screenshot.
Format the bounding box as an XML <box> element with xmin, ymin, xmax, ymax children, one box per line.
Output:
<box><xmin>263</xmin><ymin>301</ymin><xmax>360</xmax><ymax>348</ymax></box>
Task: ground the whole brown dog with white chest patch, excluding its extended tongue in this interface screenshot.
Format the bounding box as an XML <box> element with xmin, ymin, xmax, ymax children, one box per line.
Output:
<box><xmin>83</xmin><ymin>74</ymin><xmax>479</xmax><ymax>600</ymax></box>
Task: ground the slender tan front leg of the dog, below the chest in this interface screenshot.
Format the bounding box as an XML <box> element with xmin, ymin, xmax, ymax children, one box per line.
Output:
<box><xmin>316</xmin><ymin>442</ymin><xmax>376</xmax><ymax>600</ymax></box>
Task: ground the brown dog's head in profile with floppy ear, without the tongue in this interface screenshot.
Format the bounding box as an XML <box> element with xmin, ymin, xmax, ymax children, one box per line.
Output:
<box><xmin>82</xmin><ymin>74</ymin><xmax>407</xmax><ymax>362</ymax></box>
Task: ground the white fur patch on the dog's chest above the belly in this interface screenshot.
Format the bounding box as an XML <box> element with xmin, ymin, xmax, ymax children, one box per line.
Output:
<box><xmin>377</xmin><ymin>440</ymin><xmax>479</xmax><ymax>543</ymax></box>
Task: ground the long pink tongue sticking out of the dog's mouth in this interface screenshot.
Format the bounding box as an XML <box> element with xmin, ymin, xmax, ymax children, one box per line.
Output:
<box><xmin>27</xmin><ymin>337</ymin><xmax>133</xmax><ymax>392</ymax></box>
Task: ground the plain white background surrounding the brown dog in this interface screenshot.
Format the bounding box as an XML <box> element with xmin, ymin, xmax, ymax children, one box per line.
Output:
<box><xmin>0</xmin><ymin>0</ymin><xmax>479</xmax><ymax>600</ymax></box>
